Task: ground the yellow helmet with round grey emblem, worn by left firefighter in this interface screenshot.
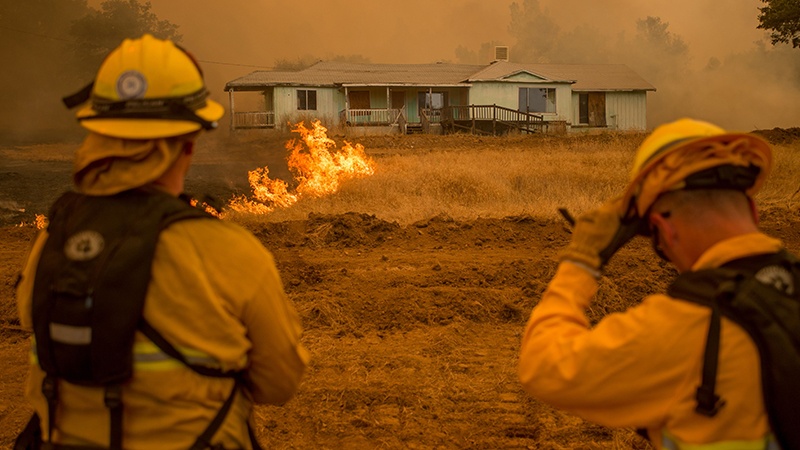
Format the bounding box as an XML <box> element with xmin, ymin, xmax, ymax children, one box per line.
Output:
<box><xmin>64</xmin><ymin>34</ymin><xmax>224</xmax><ymax>139</ymax></box>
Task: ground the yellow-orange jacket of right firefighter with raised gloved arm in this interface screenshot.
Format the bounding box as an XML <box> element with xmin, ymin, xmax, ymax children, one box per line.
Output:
<box><xmin>518</xmin><ymin>233</ymin><xmax>781</xmax><ymax>449</ymax></box>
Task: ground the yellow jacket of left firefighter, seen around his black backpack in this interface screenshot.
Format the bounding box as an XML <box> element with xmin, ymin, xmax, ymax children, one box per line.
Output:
<box><xmin>17</xmin><ymin>220</ymin><xmax>308</xmax><ymax>449</ymax></box>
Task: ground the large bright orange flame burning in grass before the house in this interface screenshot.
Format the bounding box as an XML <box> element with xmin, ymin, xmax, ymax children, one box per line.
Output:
<box><xmin>228</xmin><ymin>120</ymin><xmax>375</xmax><ymax>214</ymax></box>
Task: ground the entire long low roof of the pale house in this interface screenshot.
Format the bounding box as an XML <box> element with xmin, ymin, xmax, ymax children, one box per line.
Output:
<box><xmin>225</xmin><ymin>61</ymin><xmax>655</xmax><ymax>91</ymax></box>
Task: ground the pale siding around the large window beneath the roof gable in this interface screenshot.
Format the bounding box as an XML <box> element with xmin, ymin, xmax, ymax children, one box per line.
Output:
<box><xmin>469</xmin><ymin>82</ymin><xmax>572</xmax><ymax>121</ymax></box>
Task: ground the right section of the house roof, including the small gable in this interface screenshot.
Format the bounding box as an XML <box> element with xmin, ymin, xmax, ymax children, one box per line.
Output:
<box><xmin>468</xmin><ymin>61</ymin><xmax>656</xmax><ymax>91</ymax></box>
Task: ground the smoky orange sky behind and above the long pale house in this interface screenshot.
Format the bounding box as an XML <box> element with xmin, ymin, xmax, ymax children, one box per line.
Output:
<box><xmin>0</xmin><ymin>0</ymin><xmax>800</xmax><ymax>141</ymax></box>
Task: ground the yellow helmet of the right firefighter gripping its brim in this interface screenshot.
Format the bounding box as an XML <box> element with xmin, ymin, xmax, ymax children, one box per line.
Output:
<box><xmin>622</xmin><ymin>119</ymin><xmax>772</xmax><ymax>217</ymax></box>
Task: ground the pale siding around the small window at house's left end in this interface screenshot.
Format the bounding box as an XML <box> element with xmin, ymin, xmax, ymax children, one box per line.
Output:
<box><xmin>274</xmin><ymin>86</ymin><xmax>344</xmax><ymax>129</ymax></box>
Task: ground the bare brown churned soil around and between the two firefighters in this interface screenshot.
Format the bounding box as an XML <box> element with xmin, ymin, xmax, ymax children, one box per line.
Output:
<box><xmin>0</xmin><ymin>134</ymin><xmax>800</xmax><ymax>449</ymax></box>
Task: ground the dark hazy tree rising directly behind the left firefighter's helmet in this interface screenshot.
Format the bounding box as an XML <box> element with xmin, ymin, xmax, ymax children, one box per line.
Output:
<box><xmin>70</xmin><ymin>0</ymin><xmax>182</xmax><ymax>74</ymax></box>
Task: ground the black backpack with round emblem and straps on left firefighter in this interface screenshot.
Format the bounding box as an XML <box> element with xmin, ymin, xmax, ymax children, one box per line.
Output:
<box><xmin>15</xmin><ymin>189</ymin><xmax>259</xmax><ymax>450</ymax></box>
